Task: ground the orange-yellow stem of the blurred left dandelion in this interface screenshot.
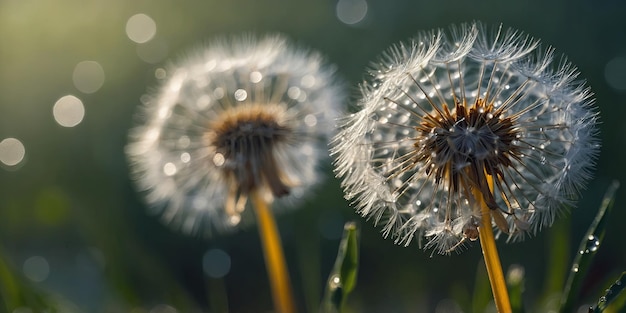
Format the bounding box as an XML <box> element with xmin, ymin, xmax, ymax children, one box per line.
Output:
<box><xmin>252</xmin><ymin>191</ymin><xmax>295</xmax><ymax>313</ymax></box>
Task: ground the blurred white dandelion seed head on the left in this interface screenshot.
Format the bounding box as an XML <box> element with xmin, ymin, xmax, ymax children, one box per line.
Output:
<box><xmin>126</xmin><ymin>35</ymin><xmax>344</xmax><ymax>234</ymax></box>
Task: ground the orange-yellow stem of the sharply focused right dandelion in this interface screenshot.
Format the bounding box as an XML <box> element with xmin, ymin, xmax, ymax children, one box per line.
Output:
<box><xmin>473</xmin><ymin>173</ymin><xmax>511</xmax><ymax>313</ymax></box>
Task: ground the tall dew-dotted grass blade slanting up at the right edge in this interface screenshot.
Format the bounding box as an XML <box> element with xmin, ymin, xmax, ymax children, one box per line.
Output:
<box><xmin>561</xmin><ymin>181</ymin><xmax>619</xmax><ymax>312</ymax></box>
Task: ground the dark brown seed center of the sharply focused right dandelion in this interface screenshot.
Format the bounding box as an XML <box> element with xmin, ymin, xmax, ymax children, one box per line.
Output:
<box><xmin>414</xmin><ymin>99</ymin><xmax>521</xmax><ymax>232</ymax></box>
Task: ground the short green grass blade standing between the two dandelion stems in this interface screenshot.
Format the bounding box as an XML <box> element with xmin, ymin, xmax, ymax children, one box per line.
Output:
<box><xmin>321</xmin><ymin>222</ymin><xmax>359</xmax><ymax>312</ymax></box>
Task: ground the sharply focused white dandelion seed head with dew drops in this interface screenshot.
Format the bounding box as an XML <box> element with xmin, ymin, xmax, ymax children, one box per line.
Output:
<box><xmin>331</xmin><ymin>23</ymin><xmax>600</xmax><ymax>253</ymax></box>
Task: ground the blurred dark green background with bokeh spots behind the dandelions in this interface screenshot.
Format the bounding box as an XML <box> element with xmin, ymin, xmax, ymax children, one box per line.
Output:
<box><xmin>0</xmin><ymin>0</ymin><xmax>626</xmax><ymax>313</ymax></box>
